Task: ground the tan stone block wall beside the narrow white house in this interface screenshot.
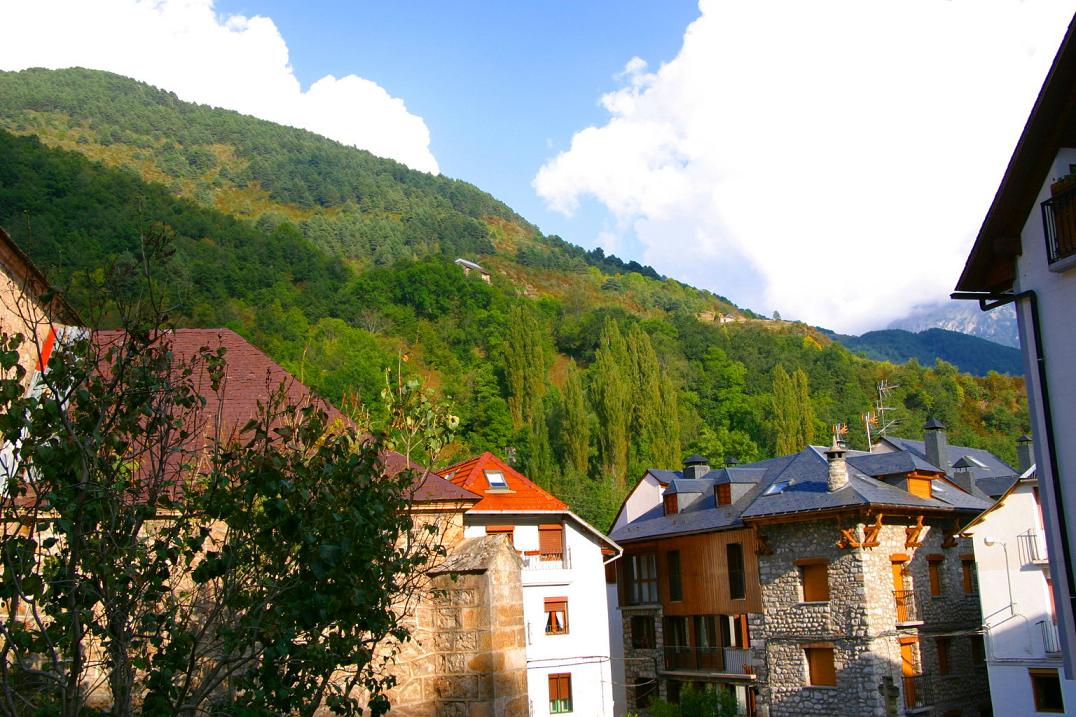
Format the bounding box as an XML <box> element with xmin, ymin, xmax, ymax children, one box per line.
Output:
<box><xmin>387</xmin><ymin>536</ymin><xmax>529</xmax><ymax>717</ymax></box>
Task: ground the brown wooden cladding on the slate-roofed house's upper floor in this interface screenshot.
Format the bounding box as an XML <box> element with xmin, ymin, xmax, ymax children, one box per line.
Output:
<box><xmin>617</xmin><ymin>529</ymin><xmax>762</xmax><ymax>616</ymax></box>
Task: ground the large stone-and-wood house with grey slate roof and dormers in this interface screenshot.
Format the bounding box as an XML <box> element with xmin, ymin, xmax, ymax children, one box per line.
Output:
<box><xmin>610</xmin><ymin>421</ymin><xmax>1015</xmax><ymax>717</ymax></box>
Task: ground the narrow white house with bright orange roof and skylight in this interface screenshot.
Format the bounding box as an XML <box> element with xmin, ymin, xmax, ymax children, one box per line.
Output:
<box><xmin>440</xmin><ymin>452</ymin><xmax>621</xmax><ymax>717</ymax></box>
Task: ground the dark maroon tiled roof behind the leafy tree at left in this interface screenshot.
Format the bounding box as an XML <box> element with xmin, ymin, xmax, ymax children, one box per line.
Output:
<box><xmin>94</xmin><ymin>328</ymin><xmax>478</xmax><ymax>503</ymax></box>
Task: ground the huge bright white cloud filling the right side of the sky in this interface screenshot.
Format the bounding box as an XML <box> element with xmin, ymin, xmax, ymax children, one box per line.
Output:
<box><xmin>534</xmin><ymin>0</ymin><xmax>1076</xmax><ymax>332</ymax></box>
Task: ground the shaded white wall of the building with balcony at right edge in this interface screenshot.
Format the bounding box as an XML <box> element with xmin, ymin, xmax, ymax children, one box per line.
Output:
<box><xmin>1011</xmin><ymin>149</ymin><xmax>1076</xmax><ymax>676</ymax></box>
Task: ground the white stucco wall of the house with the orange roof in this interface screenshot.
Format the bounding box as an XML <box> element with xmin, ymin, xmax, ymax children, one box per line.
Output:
<box><xmin>465</xmin><ymin>514</ymin><xmax>619</xmax><ymax>717</ymax></box>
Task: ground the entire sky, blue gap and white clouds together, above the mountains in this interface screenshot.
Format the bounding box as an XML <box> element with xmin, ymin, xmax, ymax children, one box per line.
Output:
<box><xmin>0</xmin><ymin>0</ymin><xmax>1076</xmax><ymax>334</ymax></box>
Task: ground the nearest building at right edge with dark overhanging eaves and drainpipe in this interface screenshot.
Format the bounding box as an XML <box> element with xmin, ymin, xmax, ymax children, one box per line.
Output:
<box><xmin>953</xmin><ymin>12</ymin><xmax>1076</xmax><ymax>680</ymax></box>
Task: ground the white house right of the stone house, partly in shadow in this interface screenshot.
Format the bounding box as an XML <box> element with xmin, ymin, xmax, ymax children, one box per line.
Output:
<box><xmin>962</xmin><ymin>467</ymin><xmax>1076</xmax><ymax>717</ymax></box>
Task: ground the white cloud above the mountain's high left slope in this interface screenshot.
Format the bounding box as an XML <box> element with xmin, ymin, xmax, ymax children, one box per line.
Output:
<box><xmin>0</xmin><ymin>0</ymin><xmax>438</xmax><ymax>173</ymax></box>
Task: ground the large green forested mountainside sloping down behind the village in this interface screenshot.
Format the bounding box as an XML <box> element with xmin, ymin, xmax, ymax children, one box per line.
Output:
<box><xmin>0</xmin><ymin>70</ymin><xmax>1028</xmax><ymax>525</ymax></box>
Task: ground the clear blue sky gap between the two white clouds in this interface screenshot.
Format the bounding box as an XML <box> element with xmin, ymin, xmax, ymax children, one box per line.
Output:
<box><xmin>215</xmin><ymin>0</ymin><xmax>698</xmax><ymax>254</ymax></box>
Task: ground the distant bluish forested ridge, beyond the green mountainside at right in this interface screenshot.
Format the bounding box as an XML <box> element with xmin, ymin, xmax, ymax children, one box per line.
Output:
<box><xmin>833</xmin><ymin>327</ymin><xmax>1023</xmax><ymax>376</ymax></box>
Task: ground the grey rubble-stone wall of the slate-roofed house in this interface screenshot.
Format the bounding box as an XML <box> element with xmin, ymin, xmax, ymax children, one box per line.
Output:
<box><xmin>752</xmin><ymin>518</ymin><xmax>989</xmax><ymax>717</ymax></box>
